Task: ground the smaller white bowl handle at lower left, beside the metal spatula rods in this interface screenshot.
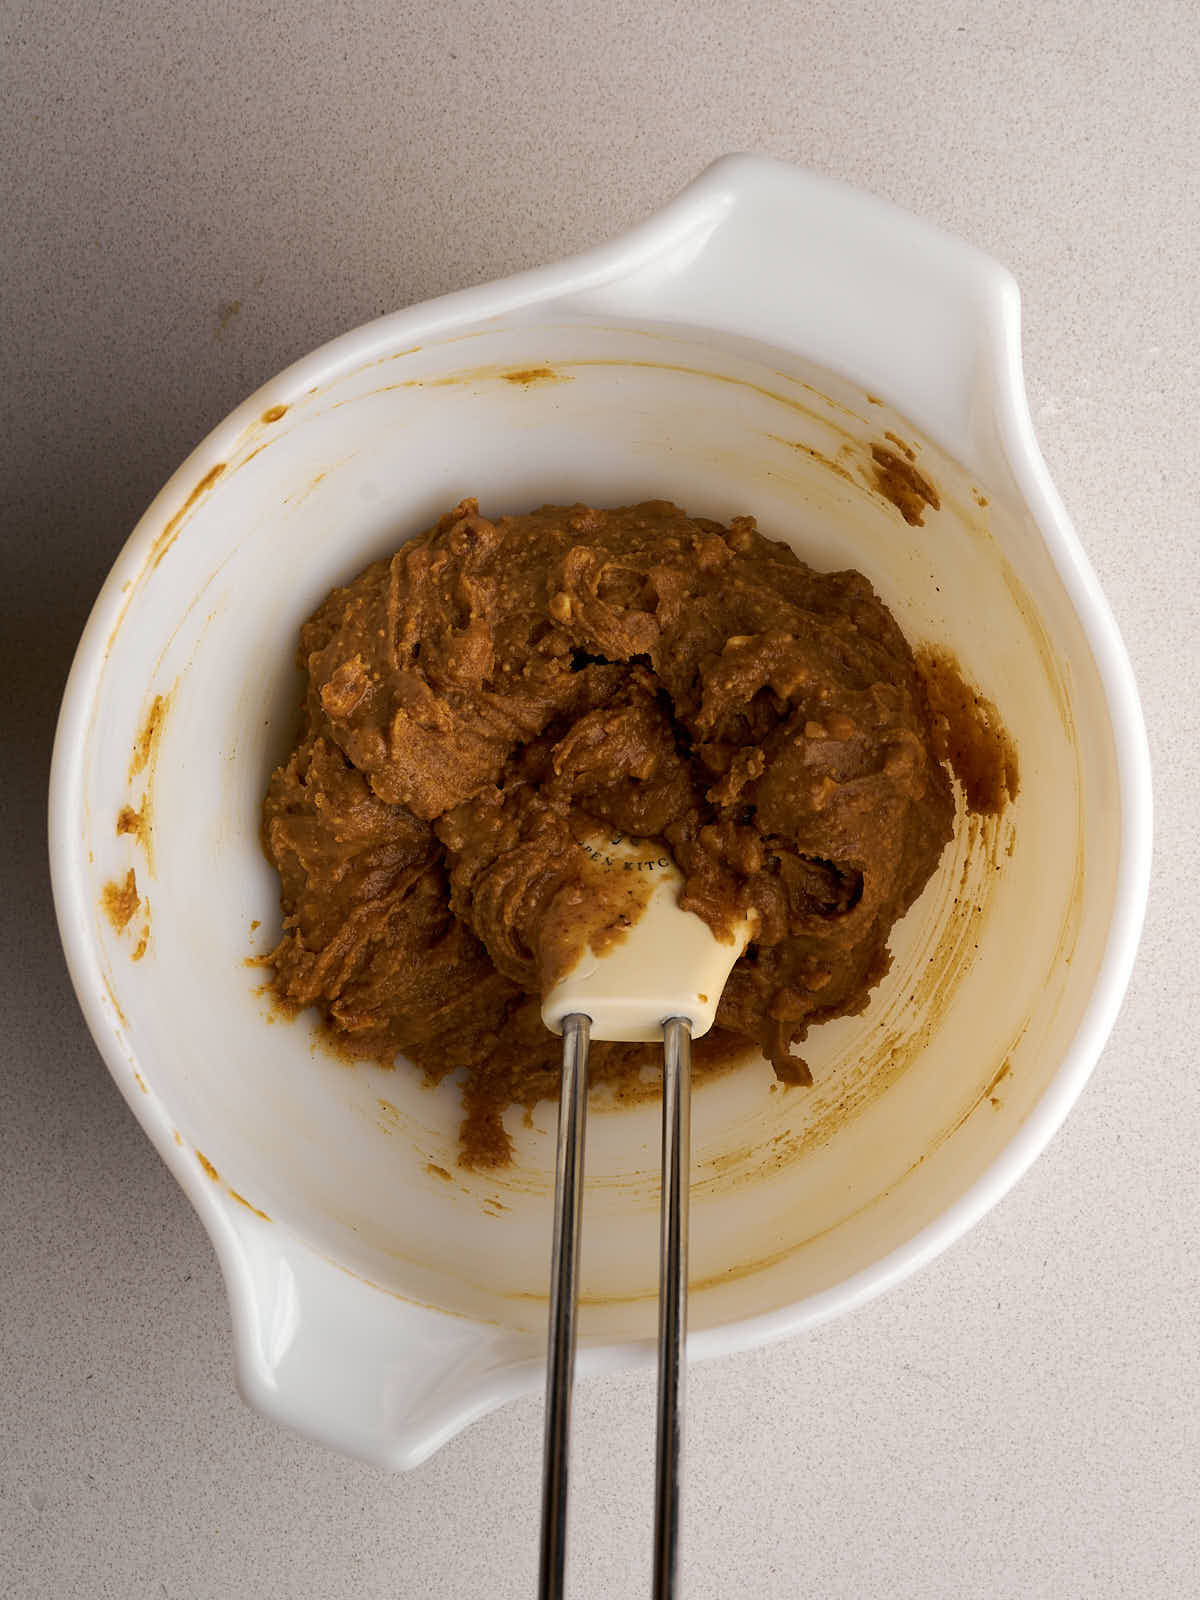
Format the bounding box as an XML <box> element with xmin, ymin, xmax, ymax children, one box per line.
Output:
<box><xmin>213</xmin><ymin>1213</ymin><xmax>544</xmax><ymax>1470</ymax></box>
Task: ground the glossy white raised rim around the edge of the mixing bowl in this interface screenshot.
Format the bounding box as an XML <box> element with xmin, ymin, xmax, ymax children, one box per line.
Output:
<box><xmin>48</xmin><ymin>155</ymin><xmax>1152</xmax><ymax>1403</ymax></box>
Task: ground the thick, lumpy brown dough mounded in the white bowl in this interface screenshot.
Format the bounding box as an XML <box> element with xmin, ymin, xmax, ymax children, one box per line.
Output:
<box><xmin>264</xmin><ymin>501</ymin><xmax>1016</xmax><ymax>1166</ymax></box>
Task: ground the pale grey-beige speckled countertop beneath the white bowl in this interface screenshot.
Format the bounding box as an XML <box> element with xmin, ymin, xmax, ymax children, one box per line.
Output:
<box><xmin>0</xmin><ymin>0</ymin><xmax>1200</xmax><ymax>1600</ymax></box>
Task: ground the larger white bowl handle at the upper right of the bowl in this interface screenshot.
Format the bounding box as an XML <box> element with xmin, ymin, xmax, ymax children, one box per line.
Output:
<box><xmin>574</xmin><ymin>155</ymin><xmax>1024</xmax><ymax>474</ymax></box>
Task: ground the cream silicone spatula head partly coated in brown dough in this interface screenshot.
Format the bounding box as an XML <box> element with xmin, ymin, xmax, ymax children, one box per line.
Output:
<box><xmin>542</xmin><ymin>837</ymin><xmax>752</xmax><ymax>1043</ymax></box>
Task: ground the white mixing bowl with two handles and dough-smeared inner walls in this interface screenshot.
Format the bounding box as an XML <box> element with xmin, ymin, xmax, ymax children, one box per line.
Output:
<box><xmin>50</xmin><ymin>157</ymin><xmax>1150</xmax><ymax>1466</ymax></box>
